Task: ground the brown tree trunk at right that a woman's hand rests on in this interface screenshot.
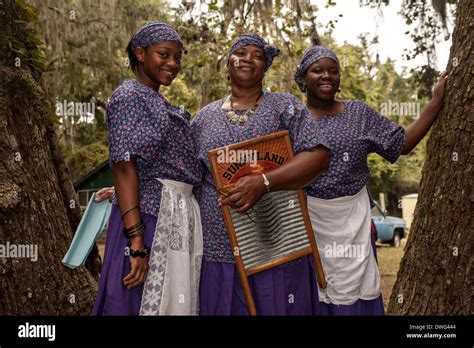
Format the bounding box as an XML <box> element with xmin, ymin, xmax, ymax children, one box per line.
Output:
<box><xmin>388</xmin><ymin>0</ymin><xmax>474</xmax><ymax>315</ymax></box>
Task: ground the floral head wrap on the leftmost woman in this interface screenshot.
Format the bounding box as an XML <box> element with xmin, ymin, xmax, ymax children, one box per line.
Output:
<box><xmin>131</xmin><ymin>21</ymin><xmax>184</xmax><ymax>50</ymax></box>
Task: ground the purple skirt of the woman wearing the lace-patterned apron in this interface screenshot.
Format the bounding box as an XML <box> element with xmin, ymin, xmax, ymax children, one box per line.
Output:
<box><xmin>92</xmin><ymin>204</ymin><xmax>157</xmax><ymax>315</ymax></box>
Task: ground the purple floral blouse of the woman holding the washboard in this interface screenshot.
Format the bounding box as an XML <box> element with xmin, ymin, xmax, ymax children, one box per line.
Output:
<box><xmin>191</xmin><ymin>93</ymin><xmax>329</xmax><ymax>262</ymax></box>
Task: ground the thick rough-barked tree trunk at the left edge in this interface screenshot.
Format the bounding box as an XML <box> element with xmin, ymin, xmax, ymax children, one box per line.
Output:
<box><xmin>0</xmin><ymin>0</ymin><xmax>97</xmax><ymax>315</ymax></box>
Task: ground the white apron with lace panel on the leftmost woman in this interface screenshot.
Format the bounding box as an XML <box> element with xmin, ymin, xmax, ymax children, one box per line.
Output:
<box><xmin>140</xmin><ymin>179</ymin><xmax>203</xmax><ymax>315</ymax></box>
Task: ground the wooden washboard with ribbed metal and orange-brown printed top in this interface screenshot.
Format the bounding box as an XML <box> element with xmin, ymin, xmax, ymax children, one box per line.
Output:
<box><xmin>208</xmin><ymin>131</ymin><xmax>326</xmax><ymax>315</ymax></box>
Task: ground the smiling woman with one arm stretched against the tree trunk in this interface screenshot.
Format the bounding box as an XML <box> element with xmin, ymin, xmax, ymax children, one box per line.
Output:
<box><xmin>295</xmin><ymin>46</ymin><xmax>448</xmax><ymax>315</ymax></box>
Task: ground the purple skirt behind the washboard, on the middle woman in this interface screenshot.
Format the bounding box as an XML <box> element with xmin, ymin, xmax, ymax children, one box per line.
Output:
<box><xmin>199</xmin><ymin>256</ymin><xmax>318</xmax><ymax>315</ymax></box>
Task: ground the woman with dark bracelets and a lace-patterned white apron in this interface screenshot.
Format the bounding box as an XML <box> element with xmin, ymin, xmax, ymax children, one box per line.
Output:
<box><xmin>93</xmin><ymin>22</ymin><xmax>202</xmax><ymax>315</ymax></box>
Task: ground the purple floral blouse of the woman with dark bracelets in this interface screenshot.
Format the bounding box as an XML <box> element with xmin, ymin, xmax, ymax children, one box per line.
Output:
<box><xmin>106</xmin><ymin>80</ymin><xmax>201</xmax><ymax>216</ymax></box>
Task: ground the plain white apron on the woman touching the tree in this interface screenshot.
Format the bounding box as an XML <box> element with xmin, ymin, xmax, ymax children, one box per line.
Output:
<box><xmin>308</xmin><ymin>186</ymin><xmax>380</xmax><ymax>305</ymax></box>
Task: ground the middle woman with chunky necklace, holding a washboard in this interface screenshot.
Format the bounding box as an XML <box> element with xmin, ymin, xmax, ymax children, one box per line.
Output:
<box><xmin>192</xmin><ymin>34</ymin><xmax>328</xmax><ymax>315</ymax></box>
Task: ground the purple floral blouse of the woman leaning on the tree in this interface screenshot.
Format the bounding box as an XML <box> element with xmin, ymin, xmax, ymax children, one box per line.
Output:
<box><xmin>305</xmin><ymin>100</ymin><xmax>405</xmax><ymax>199</ymax></box>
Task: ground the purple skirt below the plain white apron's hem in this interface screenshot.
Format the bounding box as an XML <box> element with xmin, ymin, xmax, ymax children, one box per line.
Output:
<box><xmin>318</xmin><ymin>233</ymin><xmax>385</xmax><ymax>315</ymax></box>
